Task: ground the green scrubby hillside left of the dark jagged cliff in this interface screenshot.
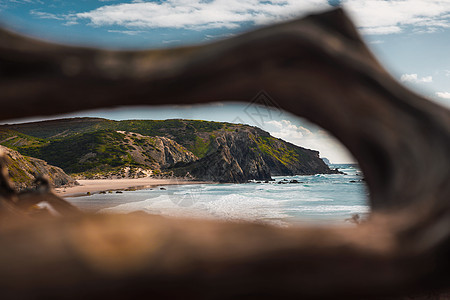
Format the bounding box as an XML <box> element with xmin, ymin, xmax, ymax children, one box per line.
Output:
<box><xmin>0</xmin><ymin>127</ymin><xmax>197</xmax><ymax>177</ymax></box>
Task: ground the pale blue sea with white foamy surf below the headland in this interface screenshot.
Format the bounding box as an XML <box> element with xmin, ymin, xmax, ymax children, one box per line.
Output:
<box><xmin>68</xmin><ymin>164</ymin><xmax>370</xmax><ymax>226</ymax></box>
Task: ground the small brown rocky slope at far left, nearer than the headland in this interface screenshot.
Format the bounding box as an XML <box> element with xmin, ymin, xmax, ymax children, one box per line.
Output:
<box><xmin>0</xmin><ymin>146</ymin><xmax>77</xmax><ymax>190</ymax></box>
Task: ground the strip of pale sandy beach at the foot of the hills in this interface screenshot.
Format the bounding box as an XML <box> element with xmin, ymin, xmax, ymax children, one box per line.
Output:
<box><xmin>54</xmin><ymin>177</ymin><xmax>214</xmax><ymax>197</ymax></box>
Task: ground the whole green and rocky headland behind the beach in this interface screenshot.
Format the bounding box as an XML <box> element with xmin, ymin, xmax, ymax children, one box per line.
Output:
<box><xmin>0</xmin><ymin>118</ymin><xmax>337</xmax><ymax>182</ymax></box>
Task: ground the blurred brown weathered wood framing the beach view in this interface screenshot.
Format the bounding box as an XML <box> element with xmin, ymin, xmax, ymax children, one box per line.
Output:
<box><xmin>0</xmin><ymin>10</ymin><xmax>450</xmax><ymax>299</ymax></box>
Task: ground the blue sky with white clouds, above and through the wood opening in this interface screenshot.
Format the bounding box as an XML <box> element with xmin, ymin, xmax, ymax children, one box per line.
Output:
<box><xmin>0</xmin><ymin>0</ymin><xmax>450</xmax><ymax>162</ymax></box>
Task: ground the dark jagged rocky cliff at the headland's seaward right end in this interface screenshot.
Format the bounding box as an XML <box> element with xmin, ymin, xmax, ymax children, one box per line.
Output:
<box><xmin>171</xmin><ymin>126</ymin><xmax>340</xmax><ymax>183</ymax></box>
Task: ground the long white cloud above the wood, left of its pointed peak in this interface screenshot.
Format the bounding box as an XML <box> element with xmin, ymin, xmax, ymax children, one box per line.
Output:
<box><xmin>76</xmin><ymin>0</ymin><xmax>329</xmax><ymax>30</ymax></box>
